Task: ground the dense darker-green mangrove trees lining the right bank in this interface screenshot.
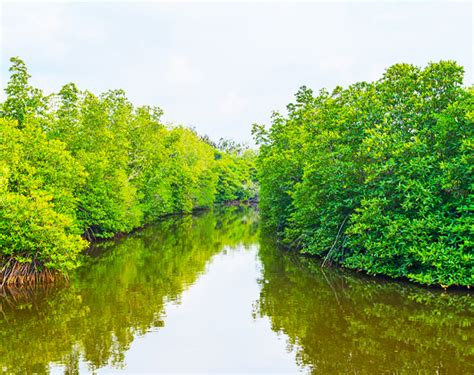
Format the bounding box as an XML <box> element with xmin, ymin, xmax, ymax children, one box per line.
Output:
<box><xmin>253</xmin><ymin>61</ymin><xmax>474</xmax><ymax>286</ymax></box>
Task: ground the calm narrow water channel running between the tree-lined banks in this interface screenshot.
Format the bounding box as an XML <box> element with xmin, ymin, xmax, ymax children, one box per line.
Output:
<box><xmin>0</xmin><ymin>207</ymin><xmax>474</xmax><ymax>374</ymax></box>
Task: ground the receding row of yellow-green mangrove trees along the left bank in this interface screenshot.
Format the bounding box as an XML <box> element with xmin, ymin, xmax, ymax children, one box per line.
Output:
<box><xmin>0</xmin><ymin>58</ymin><xmax>257</xmax><ymax>284</ymax></box>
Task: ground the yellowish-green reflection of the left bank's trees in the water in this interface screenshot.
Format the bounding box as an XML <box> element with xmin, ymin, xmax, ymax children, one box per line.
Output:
<box><xmin>0</xmin><ymin>207</ymin><xmax>257</xmax><ymax>373</ymax></box>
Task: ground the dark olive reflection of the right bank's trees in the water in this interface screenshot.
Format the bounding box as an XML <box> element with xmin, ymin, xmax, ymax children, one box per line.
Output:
<box><xmin>256</xmin><ymin>236</ymin><xmax>474</xmax><ymax>373</ymax></box>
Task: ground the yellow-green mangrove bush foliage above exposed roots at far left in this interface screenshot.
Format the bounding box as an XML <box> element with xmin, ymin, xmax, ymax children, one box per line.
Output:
<box><xmin>0</xmin><ymin>119</ymin><xmax>86</xmax><ymax>272</ymax></box>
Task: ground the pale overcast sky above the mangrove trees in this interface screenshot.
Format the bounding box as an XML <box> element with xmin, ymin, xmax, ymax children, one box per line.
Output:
<box><xmin>0</xmin><ymin>0</ymin><xmax>473</xmax><ymax>142</ymax></box>
